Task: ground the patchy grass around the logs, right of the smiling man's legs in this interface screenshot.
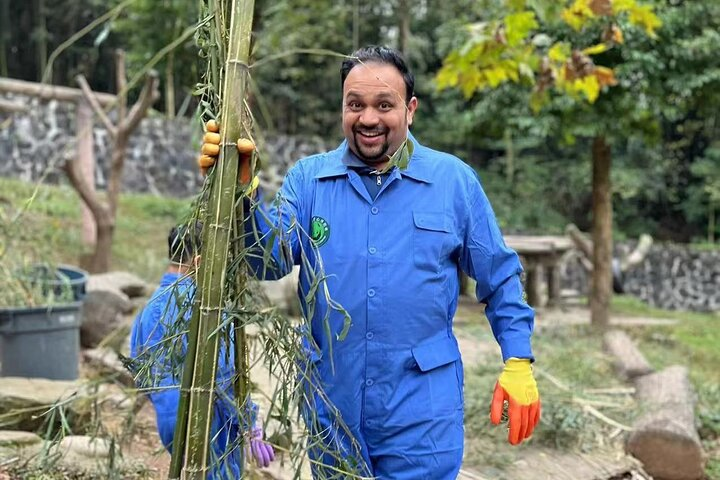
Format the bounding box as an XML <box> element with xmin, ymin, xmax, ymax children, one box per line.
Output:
<box><xmin>460</xmin><ymin>297</ymin><xmax>720</xmax><ymax>479</ymax></box>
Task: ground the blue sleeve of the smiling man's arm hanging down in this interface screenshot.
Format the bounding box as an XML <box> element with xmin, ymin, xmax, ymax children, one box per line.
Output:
<box><xmin>460</xmin><ymin>182</ymin><xmax>535</xmax><ymax>361</ymax></box>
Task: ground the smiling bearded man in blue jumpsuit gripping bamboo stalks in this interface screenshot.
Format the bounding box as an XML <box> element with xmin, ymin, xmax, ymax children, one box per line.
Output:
<box><xmin>199</xmin><ymin>47</ymin><xmax>540</xmax><ymax>480</ymax></box>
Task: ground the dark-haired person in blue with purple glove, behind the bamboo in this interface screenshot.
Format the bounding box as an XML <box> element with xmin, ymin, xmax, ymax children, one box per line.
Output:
<box><xmin>130</xmin><ymin>224</ymin><xmax>275</xmax><ymax>480</ymax></box>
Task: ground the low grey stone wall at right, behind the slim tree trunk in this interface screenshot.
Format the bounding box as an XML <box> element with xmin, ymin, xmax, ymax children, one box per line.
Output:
<box><xmin>562</xmin><ymin>244</ymin><xmax>720</xmax><ymax>312</ymax></box>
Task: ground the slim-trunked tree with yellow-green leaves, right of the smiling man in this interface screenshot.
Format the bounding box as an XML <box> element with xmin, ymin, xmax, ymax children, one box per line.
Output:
<box><xmin>437</xmin><ymin>0</ymin><xmax>661</xmax><ymax>326</ymax></box>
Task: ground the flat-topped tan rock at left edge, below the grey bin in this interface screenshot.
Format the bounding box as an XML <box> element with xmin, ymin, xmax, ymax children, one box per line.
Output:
<box><xmin>0</xmin><ymin>377</ymin><xmax>92</xmax><ymax>431</ymax></box>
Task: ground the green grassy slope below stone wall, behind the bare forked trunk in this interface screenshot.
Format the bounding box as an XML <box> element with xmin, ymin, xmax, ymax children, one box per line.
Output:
<box><xmin>0</xmin><ymin>178</ymin><xmax>191</xmax><ymax>281</ymax></box>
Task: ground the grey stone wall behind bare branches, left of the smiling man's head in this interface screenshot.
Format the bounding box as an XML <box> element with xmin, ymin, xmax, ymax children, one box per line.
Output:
<box><xmin>0</xmin><ymin>93</ymin><xmax>332</xmax><ymax>197</ymax></box>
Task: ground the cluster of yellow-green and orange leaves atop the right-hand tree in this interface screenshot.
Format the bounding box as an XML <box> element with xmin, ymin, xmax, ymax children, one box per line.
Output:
<box><xmin>436</xmin><ymin>0</ymin><xmax>661</xmax><ymax>106</ymax></box>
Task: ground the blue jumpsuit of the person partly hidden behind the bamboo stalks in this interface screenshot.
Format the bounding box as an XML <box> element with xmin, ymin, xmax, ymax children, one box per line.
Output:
<box><xmin>130</xmin><ymin>273</ymin><xmax>257</xmax><ymax>480</ymax></box>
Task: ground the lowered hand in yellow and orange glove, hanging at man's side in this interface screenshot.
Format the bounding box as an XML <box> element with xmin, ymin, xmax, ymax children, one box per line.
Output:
<box><xmin>490</xmin><ymin>358</ymin><xmax>540</xmax><ymax>445</ymax></box>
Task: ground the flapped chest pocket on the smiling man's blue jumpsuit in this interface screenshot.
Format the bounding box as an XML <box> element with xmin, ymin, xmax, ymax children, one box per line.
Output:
<box><xmin>413</xmin><ymin>212</ymin><xmax>450</xmax><ymax>273</ymax></box>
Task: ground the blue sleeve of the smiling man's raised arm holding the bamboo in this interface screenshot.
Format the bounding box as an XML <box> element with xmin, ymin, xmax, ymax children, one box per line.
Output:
<box><xmin>244</xmin><ymin>164</ymin><xmax>304</xmax><ymax>280</ymax></box>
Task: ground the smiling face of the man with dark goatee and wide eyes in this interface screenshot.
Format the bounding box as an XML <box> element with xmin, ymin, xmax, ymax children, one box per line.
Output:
<box><xmin>343</xmin><ymin>62</ymin><xmax>417</xmax><ymax>168</ymax></box>
